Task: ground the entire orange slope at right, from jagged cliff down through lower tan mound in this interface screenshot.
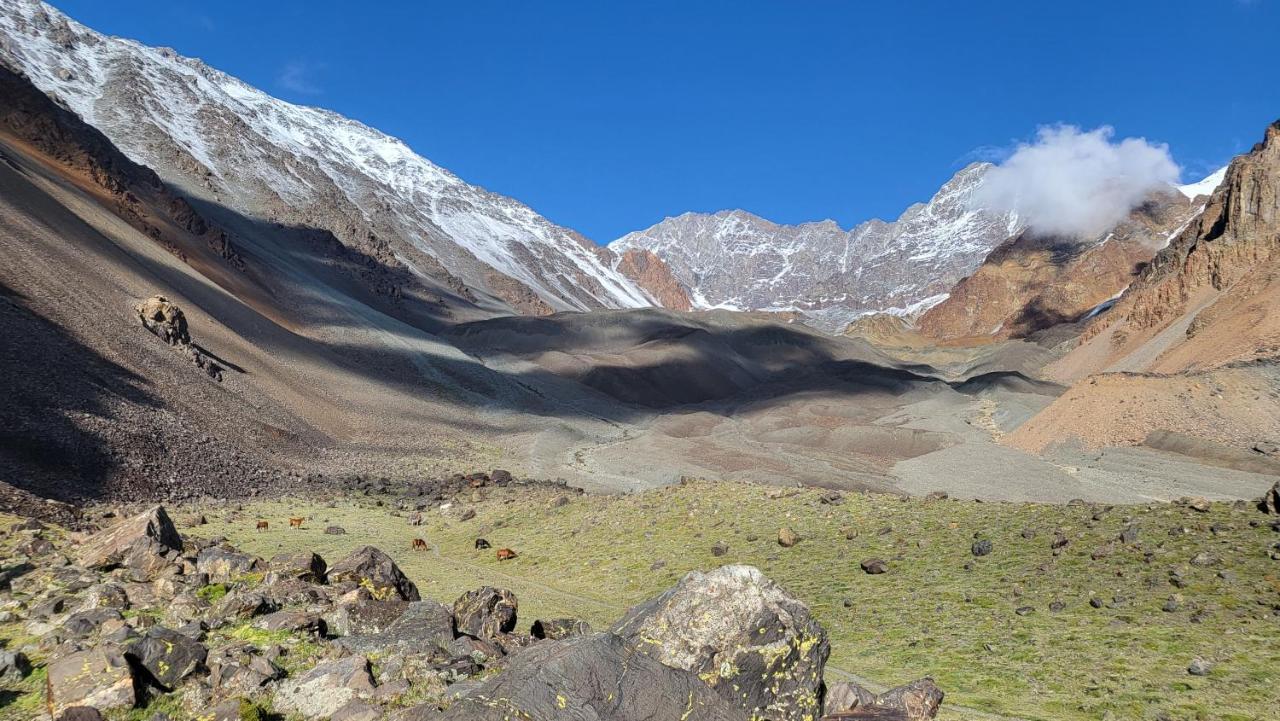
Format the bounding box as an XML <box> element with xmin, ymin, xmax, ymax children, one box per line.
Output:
<box><xmin>1009</xmin><ymin>122</ymin><xmax>1280</xmax><ymax>455</ymax></box>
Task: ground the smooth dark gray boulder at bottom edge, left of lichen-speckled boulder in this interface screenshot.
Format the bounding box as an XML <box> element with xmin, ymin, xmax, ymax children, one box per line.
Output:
<box><xmin>442</xmin><ymin>634</ymin><xmax>748</xmax><ymax>721</ymax></box>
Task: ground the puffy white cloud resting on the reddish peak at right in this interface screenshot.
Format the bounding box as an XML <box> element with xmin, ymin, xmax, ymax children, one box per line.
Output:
<box><xmin>973</xmin><ymin>126</ymin><xmax>1179</xmax><ymax>238</ymax></box>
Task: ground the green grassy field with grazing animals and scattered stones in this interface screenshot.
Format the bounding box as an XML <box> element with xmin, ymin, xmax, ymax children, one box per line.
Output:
<box><xmin>179</xmin><ymin>483</ymin><xmax>1280</xmax><ymax>721</ymax></box>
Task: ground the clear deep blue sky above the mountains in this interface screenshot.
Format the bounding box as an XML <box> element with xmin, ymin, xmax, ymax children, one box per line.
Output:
<box><xmin>54</xmin><ymin>0</ymin><xmax>1280</xmax><ymax>242</ymax></box>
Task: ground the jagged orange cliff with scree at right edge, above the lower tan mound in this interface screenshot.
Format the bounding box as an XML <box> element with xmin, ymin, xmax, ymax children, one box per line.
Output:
<box><xmin>1057</xmin><ymin>123</ymin><xmax>1280</xmax><ymax>377</ymax></box>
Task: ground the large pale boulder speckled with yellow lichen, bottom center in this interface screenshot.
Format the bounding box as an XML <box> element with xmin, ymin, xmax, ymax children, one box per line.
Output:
<box><xmin>613</xmin><ymin>566</ymin><xmax>831</xmax><ymax>721</ymax></box>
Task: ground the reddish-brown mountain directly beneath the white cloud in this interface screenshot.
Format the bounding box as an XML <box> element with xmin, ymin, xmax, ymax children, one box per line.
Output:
<box><xmin>918</xmin><ymin>188</ymin><xmax>1204</xmax><ymax>341</ymax></box>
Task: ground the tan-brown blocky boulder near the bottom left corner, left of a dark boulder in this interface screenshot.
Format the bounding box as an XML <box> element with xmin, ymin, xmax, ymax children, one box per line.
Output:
<box><xmin>46</xmin><ymin>647</ymin><xmax>137</xmax><ymax>718</ymax></box>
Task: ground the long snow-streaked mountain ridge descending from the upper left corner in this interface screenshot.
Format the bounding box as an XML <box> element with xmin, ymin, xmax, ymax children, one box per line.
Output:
<box><xmin>0</xmin><ymin>0</ymin><xmax>655</xmax><ymax>312</ymax></box>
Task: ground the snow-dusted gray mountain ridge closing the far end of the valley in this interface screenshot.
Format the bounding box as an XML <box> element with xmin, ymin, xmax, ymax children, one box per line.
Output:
<box><xmin>609</xmin><ymin>163</ymin><xmax>1023</xmax><ymax>329</ymax></box>
